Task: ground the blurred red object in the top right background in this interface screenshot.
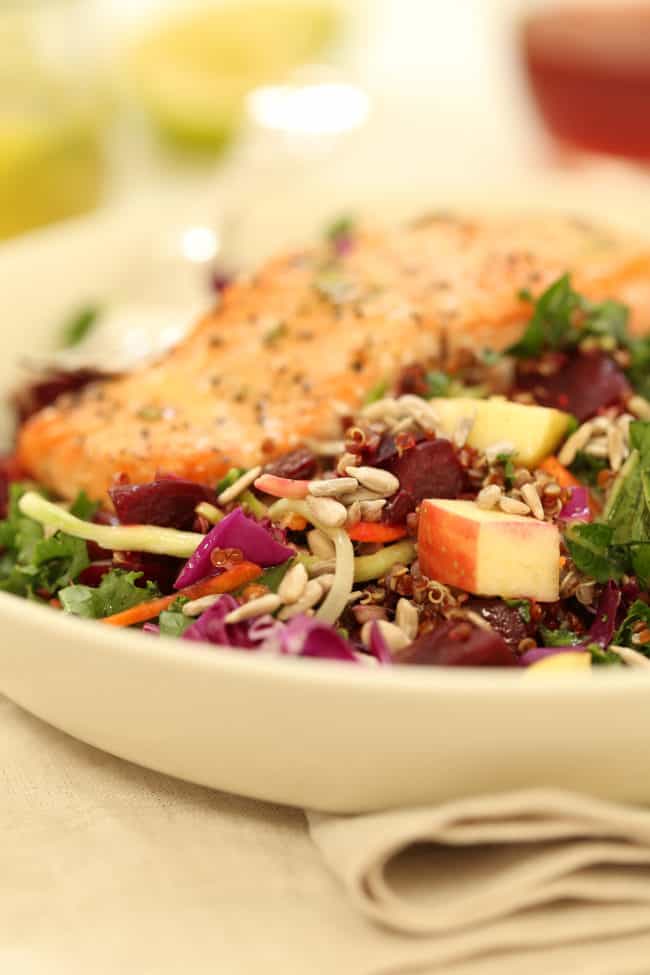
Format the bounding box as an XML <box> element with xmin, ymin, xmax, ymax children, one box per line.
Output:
<box><xmin>521</xmin><ymin>0</ymin><xmax>650</xmax><ymax>159</ymax></box>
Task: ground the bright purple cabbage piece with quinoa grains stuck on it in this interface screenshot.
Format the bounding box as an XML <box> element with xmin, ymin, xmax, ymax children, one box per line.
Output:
<box><xmin>174</xmin><ymin>508</ymin><xmax>296</xmax><ymax>589</ymax></box>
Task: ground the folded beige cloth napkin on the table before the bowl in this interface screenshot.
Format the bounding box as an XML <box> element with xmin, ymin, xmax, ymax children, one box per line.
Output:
<box><xmin>308</xmin><ymin>789</ymin><xmax>650</xmax><ymax>975</ymax></box>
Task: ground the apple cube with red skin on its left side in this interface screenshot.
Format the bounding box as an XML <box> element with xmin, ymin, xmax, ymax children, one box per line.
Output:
<box><xmin>418</xmin><ymin>498</ymin><xmax>560</xmax><ymax>603</ymax></box>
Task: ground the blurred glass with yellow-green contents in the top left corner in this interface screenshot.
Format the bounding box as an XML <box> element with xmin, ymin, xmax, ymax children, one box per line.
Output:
<box><xmin>0</xmin><ymin>0</ymin><xmax>108</xmax><ymax>239</ymax></box>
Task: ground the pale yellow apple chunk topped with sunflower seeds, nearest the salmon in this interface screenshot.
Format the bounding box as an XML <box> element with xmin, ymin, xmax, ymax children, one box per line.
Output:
<box><xmin>431</xmin><ymin>396</ymin><xmax>569</xmax><ymax>467</ymax></box>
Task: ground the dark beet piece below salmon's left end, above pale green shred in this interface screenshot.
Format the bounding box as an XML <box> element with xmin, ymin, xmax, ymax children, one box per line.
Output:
<box><xmin>108</xmin><ymin>477</ymin><xmax>216</xmax><ymax>528</ymax></box>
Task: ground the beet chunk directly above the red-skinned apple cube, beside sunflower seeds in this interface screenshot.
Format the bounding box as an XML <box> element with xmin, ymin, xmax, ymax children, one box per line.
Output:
<box><xmin>385</xmin><ymin>438</ymin><xmax>465</xmax><ymax>504</ymax></box>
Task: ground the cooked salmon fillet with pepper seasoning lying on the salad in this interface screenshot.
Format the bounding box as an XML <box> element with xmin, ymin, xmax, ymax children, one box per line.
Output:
<box><xmin>18</xmin><ymin>214</ymin><xmax>650</xmax><ymax>498</ymax></box>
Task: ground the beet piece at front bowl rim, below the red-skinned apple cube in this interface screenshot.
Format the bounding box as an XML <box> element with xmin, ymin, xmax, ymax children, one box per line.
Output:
<box><xmin>398</xmin><ymin>620</ymin><xmax>519</xmax><ymax>667</ymax></box>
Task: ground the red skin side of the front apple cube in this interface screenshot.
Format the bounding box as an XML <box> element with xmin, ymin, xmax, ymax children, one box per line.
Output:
<box><xmin>418</xmin><ymin>501</ymin><xmax>480</xmax><ymax>592</ymax></box>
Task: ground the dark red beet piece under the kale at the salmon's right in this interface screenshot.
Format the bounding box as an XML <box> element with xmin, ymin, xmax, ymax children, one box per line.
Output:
<box><xmin>517</xmin><ymin>351</ymin><xmax>632</xmax><ymax>423</ymax></box>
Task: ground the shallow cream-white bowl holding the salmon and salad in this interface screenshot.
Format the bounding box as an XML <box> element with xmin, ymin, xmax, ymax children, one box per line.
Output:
<box><xmin>0</xmin><ymin>172</ymin><xmax>650</xmax><ymax>812</ymax></box>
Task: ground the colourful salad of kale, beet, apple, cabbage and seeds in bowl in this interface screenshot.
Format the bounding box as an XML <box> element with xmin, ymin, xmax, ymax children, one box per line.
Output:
<box><xmin>0</xmin><ymin>275</ymin><xmax>650</xmax><ymax>672</ymax></box>
